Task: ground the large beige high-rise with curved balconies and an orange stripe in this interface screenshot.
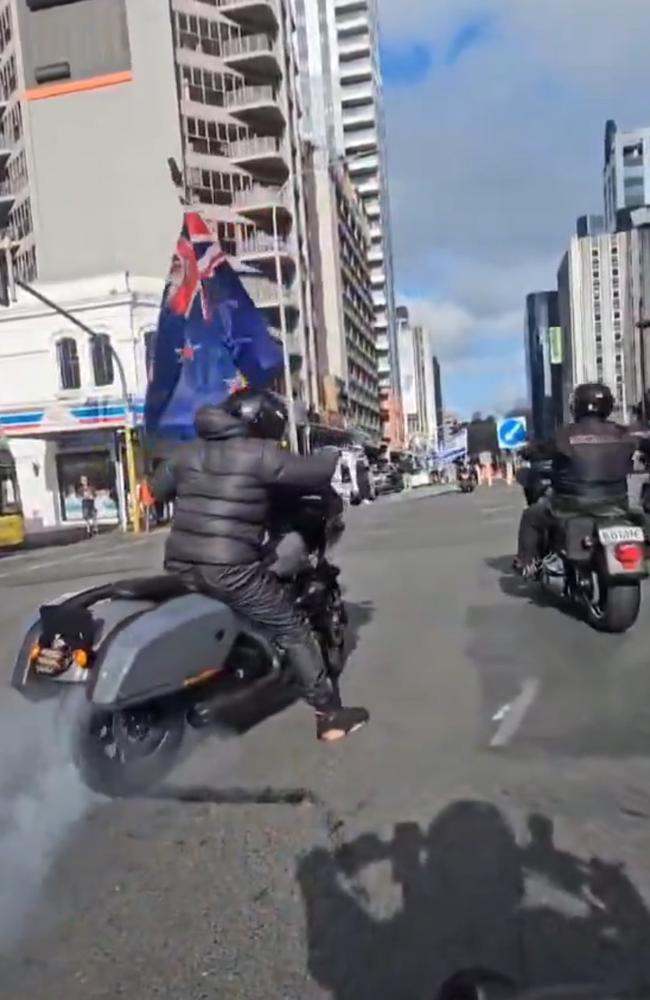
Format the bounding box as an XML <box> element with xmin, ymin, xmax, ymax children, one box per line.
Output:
<box><xmin>0</xmin><ymin>0</ymin><xmax>317</xmax><ymax>402</ymax></box>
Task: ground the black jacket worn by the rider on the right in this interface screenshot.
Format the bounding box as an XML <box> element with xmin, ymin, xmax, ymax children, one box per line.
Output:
<box><xmin>527</xmin><ymin>417</ymin><xmax>650</xmax><ymax>503</ymax></box>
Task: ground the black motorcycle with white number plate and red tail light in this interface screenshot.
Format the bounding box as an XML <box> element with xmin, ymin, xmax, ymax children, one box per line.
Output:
<box><xmin>539</xmin><ymin>511</ymin><xmax>648</xmax><ymax>633</ymax></box>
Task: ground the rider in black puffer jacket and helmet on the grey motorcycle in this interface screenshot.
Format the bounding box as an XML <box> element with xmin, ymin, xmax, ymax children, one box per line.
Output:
<box><xmin>152</xmin><ymin>390</ymin><xmax>369</xmax><ymax>742</ymax></box>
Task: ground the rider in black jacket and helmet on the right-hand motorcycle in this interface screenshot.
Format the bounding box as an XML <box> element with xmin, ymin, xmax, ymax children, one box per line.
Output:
<box><xmin>515</xmin><ymin>382</ymin><xmax>650</xmax><ymax>577</ymax></box>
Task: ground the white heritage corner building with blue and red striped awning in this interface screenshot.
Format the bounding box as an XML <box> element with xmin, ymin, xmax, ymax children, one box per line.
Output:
<box><xmin>0</xmin><ymin>273</ymin><xmax>164</xmax><ymax>531</ymax></box>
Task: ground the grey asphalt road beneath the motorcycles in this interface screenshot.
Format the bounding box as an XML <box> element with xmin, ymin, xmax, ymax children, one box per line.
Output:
<box><xmin>0</xmin><ymin>487</ymin><xmax>650</xmax><ymax>1000</ymax></box>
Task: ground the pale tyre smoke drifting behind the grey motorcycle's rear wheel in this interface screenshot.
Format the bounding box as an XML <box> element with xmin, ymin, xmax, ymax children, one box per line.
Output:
<box><xmin>0</xmin><ymin>694</ymin><xmax>94</xmax><ymax>951</ymax></box>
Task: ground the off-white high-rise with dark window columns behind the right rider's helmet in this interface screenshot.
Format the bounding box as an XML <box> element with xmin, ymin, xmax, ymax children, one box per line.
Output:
<box><xmin>558</xmin><ymin>233</ymin><xmax>635</xmax><ymax>420</ymax></box>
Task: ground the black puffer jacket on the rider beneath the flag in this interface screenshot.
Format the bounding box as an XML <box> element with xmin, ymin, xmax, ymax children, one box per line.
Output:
<box><xmin>152</xmin><ymin>406</ymin><xmax>337</xmax><ymax>566</ymax></box>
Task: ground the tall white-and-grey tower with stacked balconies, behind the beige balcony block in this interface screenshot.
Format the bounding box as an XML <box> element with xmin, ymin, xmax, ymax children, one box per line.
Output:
<box><xmin>296</xmin><ymin>0</ymin><xmax>400</xmax><ymax>437</ymax></box>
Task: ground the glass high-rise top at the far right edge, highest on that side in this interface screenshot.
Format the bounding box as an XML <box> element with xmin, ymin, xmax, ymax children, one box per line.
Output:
<box><xmin>604</xmin><ymin>121</ymin><xmax>650</xmax><ymax>232</ymax></box>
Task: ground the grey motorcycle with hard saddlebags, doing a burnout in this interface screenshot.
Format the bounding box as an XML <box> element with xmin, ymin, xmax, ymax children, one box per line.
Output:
<box><xmin>12</xmin><ymin>498</ymin><xmax>347</xmax><ymax>797</ymax></box>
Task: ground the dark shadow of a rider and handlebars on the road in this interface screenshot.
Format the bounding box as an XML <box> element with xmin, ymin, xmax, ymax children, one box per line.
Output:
<box><xmin>297</xmin><ymin>801</ymin><xmax>650</xmax><ymax>1000</ymax></box>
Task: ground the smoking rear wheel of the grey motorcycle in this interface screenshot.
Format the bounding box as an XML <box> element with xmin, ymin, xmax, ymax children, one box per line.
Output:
<box><xmin>67</xmin><ymin>703</ymin><xmax>185</xmax><ymax>798</ymax></box>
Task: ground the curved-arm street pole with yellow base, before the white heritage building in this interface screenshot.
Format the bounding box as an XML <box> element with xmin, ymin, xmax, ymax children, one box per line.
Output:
<box><xmin>0</xmin><ymin>236</ymin><xmax>140</xmax><ymax>534</ymax></box>
